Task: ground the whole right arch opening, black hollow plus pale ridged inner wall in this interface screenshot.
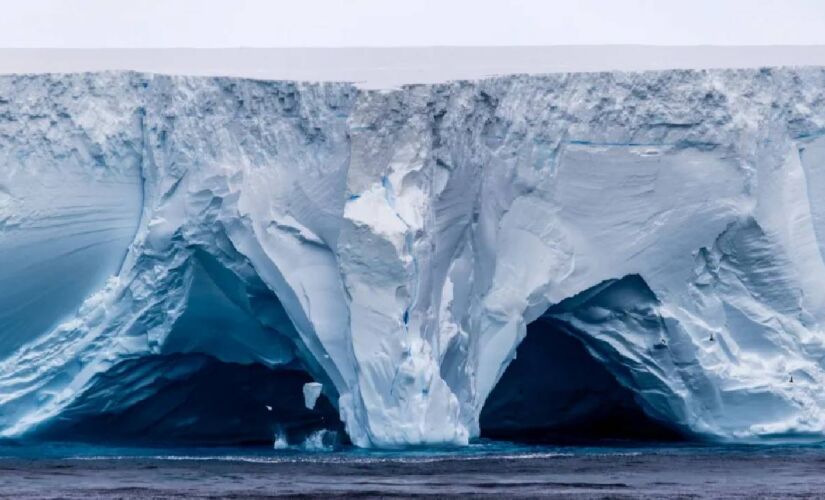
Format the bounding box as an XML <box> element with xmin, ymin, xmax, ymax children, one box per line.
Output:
<box><xmin>480</xmin><ymin>275</ymin><xmax>698</xmax><ymax>441</ymax></box>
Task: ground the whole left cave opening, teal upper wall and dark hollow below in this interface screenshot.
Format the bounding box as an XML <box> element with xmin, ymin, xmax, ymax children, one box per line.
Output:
<box><xmin>31</xmin><ymin>250</ymin><xmax>346</xmax><ymax>446</ymax></box>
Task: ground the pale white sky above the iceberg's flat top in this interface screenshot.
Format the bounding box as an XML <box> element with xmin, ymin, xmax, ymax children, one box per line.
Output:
<box><xmin>0</xmin><ymin>0</ymin><xmax>825</xmax><ymax>48</ymax></box>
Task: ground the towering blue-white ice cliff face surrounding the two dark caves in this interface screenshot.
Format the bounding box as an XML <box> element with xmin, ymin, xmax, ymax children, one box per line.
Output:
<box><xmin>0</xmin><ymin>68</ymin><xmax>825</xmax><ymax>447</ymax></box>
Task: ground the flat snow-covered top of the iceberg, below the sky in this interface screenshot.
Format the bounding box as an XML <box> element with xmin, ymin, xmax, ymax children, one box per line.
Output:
<box><xmin>0</xmin><ymin>45</ymin><xmax>825</xmax><ymax>89</ymax></box>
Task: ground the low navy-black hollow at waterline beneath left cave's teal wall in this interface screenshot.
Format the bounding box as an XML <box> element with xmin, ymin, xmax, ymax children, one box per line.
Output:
<box><xmin>35</xmin><ymin>354</ymin><xmax>344</xmax><ymax>446</ymax></box>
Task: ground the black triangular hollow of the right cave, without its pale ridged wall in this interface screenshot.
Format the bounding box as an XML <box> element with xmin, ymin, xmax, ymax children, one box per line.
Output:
<box><xmin>480</xmin><ymin>317</ymin><xmax>685</xmax><ymax>444</ymax></box>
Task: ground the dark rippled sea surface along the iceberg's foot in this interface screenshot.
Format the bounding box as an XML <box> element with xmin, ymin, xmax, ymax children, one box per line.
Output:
<box><xmin>0</xmin><ymin>442</ymin><xmax>825</xmax><ymax>499</ymax></box>
